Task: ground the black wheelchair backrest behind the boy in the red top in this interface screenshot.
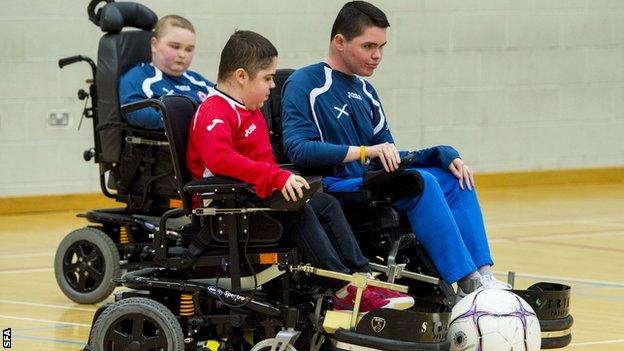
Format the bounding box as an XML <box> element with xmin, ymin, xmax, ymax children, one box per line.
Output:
<box><xmin>160</xmin><ymin>95</ymin><xmax>197</xmax><ymax>211</ymax></box>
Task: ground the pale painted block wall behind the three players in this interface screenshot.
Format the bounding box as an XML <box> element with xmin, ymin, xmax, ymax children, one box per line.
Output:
<box><xmin>0</xmin><ymin>0</ymin><xmax>624</xmax><ymax>196</ymax></box>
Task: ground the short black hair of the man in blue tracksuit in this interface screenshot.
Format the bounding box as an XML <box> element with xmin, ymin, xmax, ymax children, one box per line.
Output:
<box><xmin>329</xmin><ymin>1</ymin><xmax>390</xmax><ymax>40</ymax></box>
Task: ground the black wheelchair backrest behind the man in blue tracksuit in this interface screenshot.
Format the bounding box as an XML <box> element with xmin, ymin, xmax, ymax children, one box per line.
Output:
<box><xmin>262</xmin><ymin>68</ymin><xmax>295</xmax><ymax>164</ymax></box>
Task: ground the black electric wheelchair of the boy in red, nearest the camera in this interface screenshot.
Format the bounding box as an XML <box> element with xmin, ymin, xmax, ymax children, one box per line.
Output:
<box><xmin>81</xmin><ymin>96</ymin><xmax>450</xmax><ymax>351</ymax></box>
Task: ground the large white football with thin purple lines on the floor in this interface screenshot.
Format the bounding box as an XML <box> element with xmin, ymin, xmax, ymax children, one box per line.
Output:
<box><xmin>448</xmin><ymin>288</ymin><xmax>541</xmax><ymax>351</ymax></box>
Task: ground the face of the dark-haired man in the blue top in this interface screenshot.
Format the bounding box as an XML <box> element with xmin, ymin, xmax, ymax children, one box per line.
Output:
<box><xmin>337</xmin><ymin>26</ymin><xmax>386</xmax><ymax>77</ymax></box>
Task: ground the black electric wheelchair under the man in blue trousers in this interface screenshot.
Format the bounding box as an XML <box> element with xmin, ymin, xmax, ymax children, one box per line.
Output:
<box><xmin>263</xmin><ymin>69</ymin><xmax>574</xmax><ymax>349</ymax></box>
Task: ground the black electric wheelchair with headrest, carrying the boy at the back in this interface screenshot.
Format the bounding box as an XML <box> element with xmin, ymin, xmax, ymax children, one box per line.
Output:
<box><xmin>54</xmin><ymin>0</ymin><xmax>186</xmax><ymax>303</ymax></box>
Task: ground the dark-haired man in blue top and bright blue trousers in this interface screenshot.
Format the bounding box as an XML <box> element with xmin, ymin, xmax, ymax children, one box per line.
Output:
<box><xmin>282</xmin><ymin>1</ymin><xmax>496</xmax><ymax>296</ymax></box>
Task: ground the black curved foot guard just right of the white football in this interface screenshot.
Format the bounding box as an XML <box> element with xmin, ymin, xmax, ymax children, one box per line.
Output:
<box><xmin>513</xmin><ymin>282</ymin><xmax>574</xmax><ymax>349</ymax></box>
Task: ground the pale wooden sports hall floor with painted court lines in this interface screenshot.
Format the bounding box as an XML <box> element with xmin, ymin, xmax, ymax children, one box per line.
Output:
<box><xmin>0</xmin><ymin>183</ymin><xmax>624</xmax><ymax>351</ymax></box>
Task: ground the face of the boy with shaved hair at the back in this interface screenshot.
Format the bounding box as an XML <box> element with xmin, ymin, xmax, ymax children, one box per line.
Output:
<box><xmin>151</xmin><ymin>25</ymin><xmax>195</xmax><ymax>77</ymax></box>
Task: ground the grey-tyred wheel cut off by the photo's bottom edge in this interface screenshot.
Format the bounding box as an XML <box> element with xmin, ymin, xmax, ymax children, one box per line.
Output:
<box><xmin>89</xmin><ymin>297</ymin><xmax>184</xmax><ymax>351</ymax></box>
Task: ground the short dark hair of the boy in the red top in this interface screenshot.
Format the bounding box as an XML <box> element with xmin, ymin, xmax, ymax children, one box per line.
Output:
<box><xmin>218</xmin><ymin>30</ymin><xmax>277</xmax><ymax>80</ymax></box>
